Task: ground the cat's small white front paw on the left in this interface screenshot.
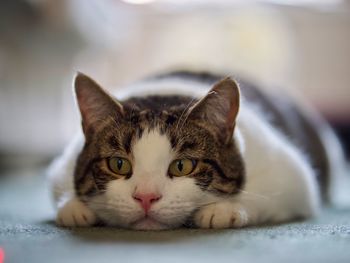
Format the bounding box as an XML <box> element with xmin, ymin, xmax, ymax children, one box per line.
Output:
<box><xmin>56</xmin><ymin>198</ymin><xmax>96</xmax><ymax>227</ymax></box>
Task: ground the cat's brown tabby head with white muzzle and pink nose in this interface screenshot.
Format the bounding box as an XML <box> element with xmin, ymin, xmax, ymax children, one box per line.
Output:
<box><xmin>74</xmin><ymin>74</ymin><xmax>244</xmax><ymax>229</ymax></box>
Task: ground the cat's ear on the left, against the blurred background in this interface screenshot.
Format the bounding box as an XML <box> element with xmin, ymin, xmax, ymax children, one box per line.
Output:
<box><xmin>74</xmin><ymin>72</ymin><xmax>123</xmax><ymax>134</ymax></box>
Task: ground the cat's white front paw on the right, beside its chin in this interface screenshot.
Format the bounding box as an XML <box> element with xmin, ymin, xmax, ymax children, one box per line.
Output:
<box><xmin>194</xmin><ymin>202</ymin><xmax>248</xmax><ymax>229</ymax></box>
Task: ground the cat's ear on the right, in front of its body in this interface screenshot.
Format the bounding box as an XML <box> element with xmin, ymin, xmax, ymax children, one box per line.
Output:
<box><xmin>189</xmin><ymin>78</ymin><xmax>240</xmax><ymax>143</ymax></box>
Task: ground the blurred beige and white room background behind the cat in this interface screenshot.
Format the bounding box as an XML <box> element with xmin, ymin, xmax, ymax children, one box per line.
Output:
<box><xmin>0</xmin><ymin>0</ymin><xmax>350</xmax><ymax>168</ymax></box>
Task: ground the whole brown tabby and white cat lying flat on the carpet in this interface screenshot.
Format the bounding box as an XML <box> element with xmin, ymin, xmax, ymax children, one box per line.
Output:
<box><xmin>49</xmin><ymin>72</ymin><xmax>344</xmax><ymax>230</ymax></box>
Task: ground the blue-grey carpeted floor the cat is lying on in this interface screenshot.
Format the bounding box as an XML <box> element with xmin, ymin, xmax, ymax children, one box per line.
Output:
<box><xmin>0</xmin><ymin>169</ymin><xmax>350</xmax><ymax>263</ymax></box>
